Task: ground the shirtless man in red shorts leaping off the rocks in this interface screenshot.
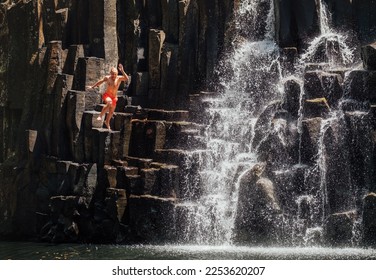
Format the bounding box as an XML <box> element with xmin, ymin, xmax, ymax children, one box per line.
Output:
<box><xmin>88</xmin><ymin>64</ymin><xmax>129</xmax><ymax>130</ymax></box>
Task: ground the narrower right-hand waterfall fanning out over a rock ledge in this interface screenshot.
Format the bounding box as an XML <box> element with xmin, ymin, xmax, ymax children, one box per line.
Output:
<box><xmin>294</xmin><ymin>0</ymin><xmax>359</xmax><ymax>245</ymax></box>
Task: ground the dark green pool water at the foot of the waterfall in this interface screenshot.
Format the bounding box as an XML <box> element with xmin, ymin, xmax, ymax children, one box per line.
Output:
<box><xmin>0</xmin><ymin>242</ymin><xmax>376</xmax><ymax>260</ymax></box>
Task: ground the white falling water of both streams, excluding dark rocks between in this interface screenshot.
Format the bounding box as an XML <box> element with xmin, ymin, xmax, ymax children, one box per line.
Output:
<box><xmin>184</xmin><ymin>0</ymin><xmax>362</xmax><ymax>245</ymax></box>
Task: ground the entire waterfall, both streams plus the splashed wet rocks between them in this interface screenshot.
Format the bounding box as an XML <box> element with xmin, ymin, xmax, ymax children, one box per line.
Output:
<box><xmin>182</xmin><ymin>0</ymin><xmax>368</xmax><ymax>245</ymax></box>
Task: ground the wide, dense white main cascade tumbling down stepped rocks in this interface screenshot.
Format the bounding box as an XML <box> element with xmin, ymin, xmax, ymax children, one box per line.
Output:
<box><xmin>181</xmin><ymin>0</ymin><xmax>280</xmax><ymax>244</ymax></box>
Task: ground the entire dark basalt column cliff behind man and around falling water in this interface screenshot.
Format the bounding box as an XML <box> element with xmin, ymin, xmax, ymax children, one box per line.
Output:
<box><xmin>0</xmin><ymin>0</ymin><xmax>376</xmax><ymax>246</ymax></box>
